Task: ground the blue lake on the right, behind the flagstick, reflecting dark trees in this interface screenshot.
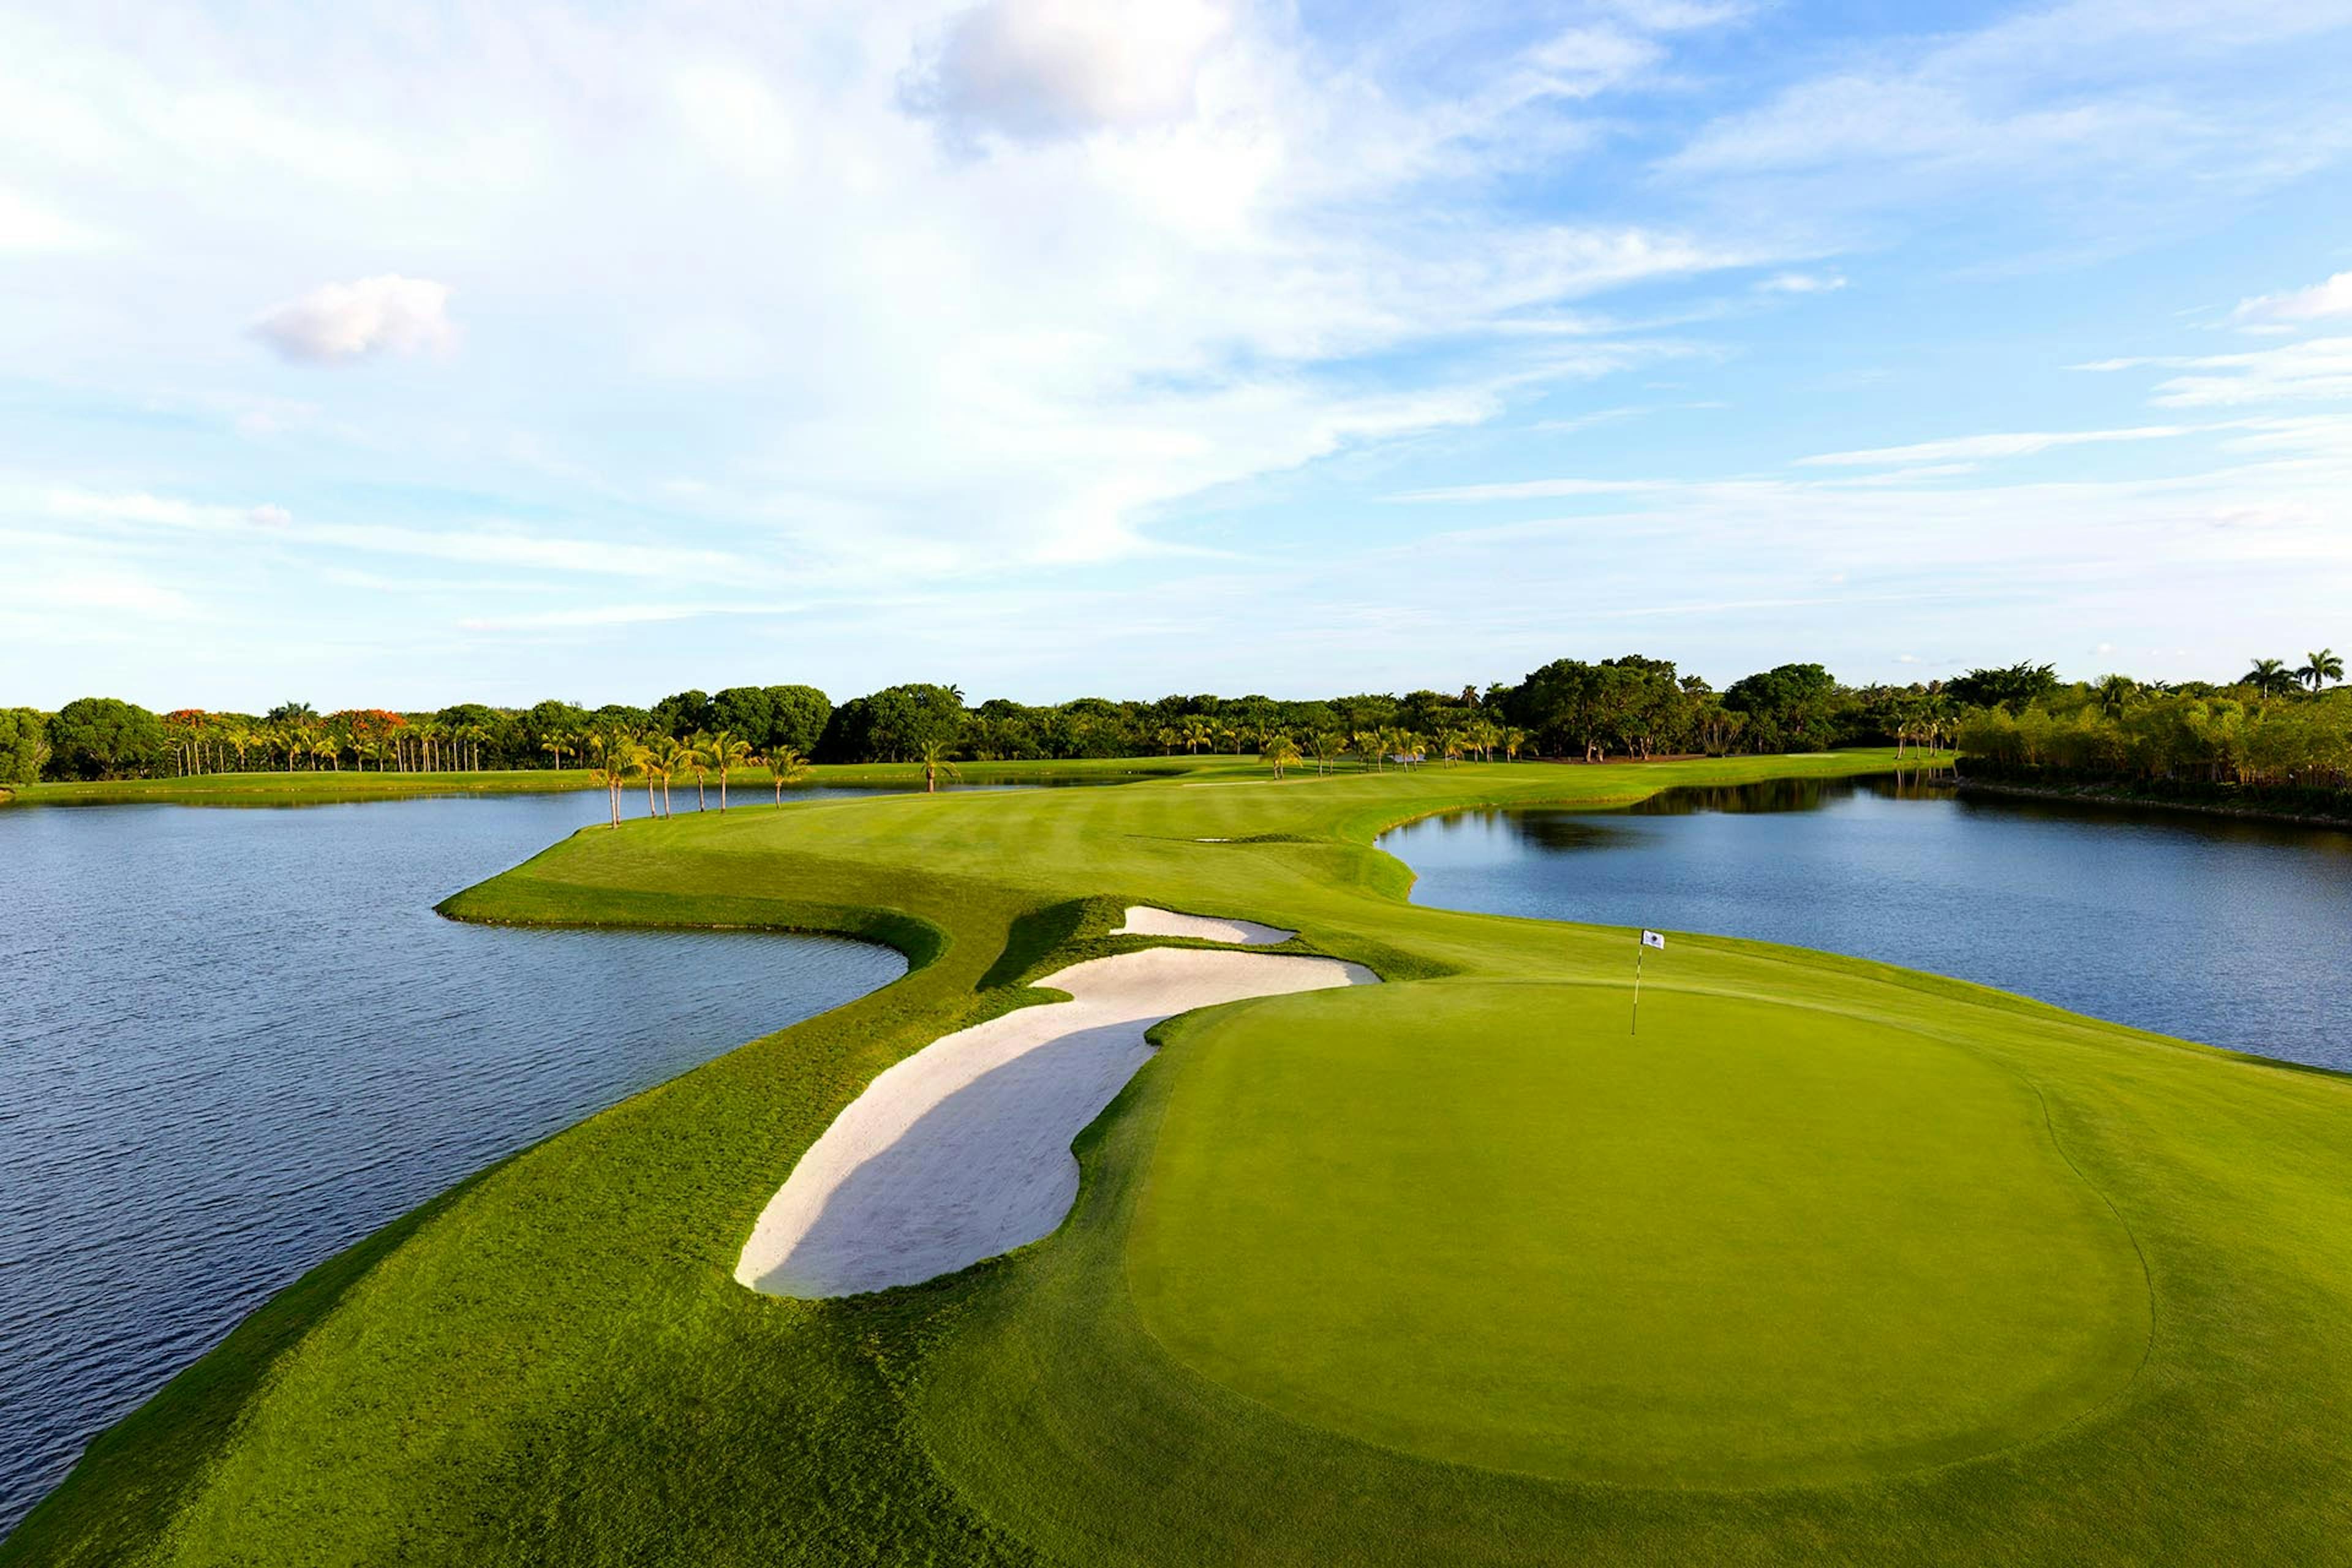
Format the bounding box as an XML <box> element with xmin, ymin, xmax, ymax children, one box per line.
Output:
<box><xmin>1381</xmin><ymin>778</ymin><xmax>2352</xmax><ymax>1069</ymax></box>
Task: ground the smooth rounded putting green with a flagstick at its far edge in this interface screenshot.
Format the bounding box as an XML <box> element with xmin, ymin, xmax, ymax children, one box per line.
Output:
<box><xmin>1126</xmin><ymin>980</ymin><xmax>2150</xmax><ymax>1486</ymax></box>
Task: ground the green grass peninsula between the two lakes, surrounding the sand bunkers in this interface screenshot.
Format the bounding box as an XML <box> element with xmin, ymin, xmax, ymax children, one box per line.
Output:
<box><xmin>0</xmin><ymin>755</ymin><xmax>2352</xmax><ymax>1568</ymax></box>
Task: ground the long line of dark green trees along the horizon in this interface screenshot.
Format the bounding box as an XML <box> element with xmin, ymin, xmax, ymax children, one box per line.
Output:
<box><xmin>0</xmin><ymin>649</ymin><xmax>2345</xmax><ymax>790</ymax></box>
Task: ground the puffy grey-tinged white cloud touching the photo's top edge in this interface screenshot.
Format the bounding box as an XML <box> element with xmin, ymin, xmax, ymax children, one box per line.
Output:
<box><xmin>903</xmin><ymin>0</ymin><xmax>1232</xmax><ymax>141</ymax></box>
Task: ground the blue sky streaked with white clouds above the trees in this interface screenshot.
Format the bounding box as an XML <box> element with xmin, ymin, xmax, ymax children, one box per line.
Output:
<box><xmin>0</xmin><ymin>0</ymin><xmax>2352</xmax><ymax>710</ymax></box>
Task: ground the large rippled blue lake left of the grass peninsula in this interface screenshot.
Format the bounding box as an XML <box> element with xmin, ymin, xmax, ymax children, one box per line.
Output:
<box><xmin>0</xmin><ymin>790</ymin><xmax>905</xmax><ymax>1532</ymax></box>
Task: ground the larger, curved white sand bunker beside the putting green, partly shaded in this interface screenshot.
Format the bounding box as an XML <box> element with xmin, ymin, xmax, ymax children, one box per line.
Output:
<box><xmin>736</xmin><ymin>930</ymin><xmax>1378</xmax><ymax>1295</ymax></box>
